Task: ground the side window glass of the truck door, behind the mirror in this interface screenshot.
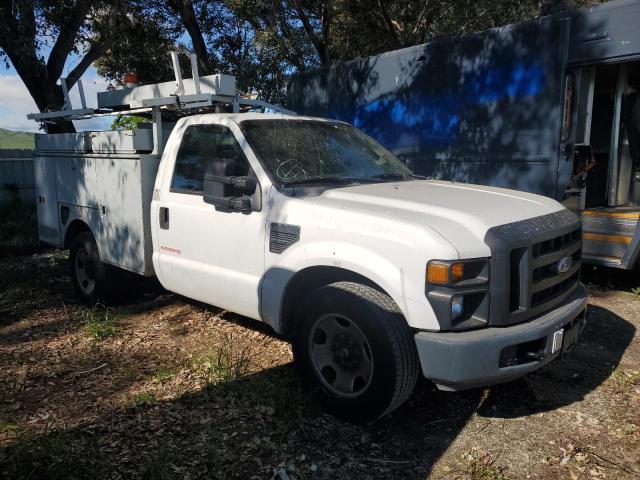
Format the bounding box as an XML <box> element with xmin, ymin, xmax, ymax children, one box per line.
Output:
<box><xmin>171</xmin><ymin>125</ymin><xmax>249</xmax><ymax>194</ymax></box>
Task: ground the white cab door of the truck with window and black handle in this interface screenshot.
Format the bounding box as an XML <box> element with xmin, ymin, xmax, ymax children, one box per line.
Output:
<box><xmin>151</xmin><ymin>124</ymin><xmax>266</xmax><ymax>319</ymax></box>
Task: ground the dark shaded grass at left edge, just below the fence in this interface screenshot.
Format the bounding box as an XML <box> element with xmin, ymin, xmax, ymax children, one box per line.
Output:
<box><xmin>0</xmin><ymin>199</ymin><xmax>40</xmax><ymax>256</ymax></box>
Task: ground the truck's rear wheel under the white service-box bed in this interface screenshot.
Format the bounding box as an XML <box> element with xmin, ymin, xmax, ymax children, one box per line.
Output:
<box><xmin>69</xmin><ymin>232</ymin><xmax>109</xmax><ymax>306</ymax></box>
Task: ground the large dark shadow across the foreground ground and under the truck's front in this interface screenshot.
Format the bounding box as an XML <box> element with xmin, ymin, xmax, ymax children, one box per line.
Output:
<box><xmin>0</xmin><ymin>294</ymin><xmax>635</xmax><ymax>479</ymax></box>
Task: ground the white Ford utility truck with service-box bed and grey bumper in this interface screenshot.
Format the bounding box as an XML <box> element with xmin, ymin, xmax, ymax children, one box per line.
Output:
<box><xmin>35</xmin><ymin>113</ymin><xmax>587</xmax><ymax>419</ymax></box>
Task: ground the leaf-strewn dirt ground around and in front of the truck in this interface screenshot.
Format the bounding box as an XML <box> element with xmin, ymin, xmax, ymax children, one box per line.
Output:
<box><xmin>0</xmin><ymin>253</ymin><xmax>640</xmax><ymax>480</ymax></box>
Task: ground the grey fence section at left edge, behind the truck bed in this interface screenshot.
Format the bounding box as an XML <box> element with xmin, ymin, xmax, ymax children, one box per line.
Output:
<box><xmin>0</xmin><ymin>150</ymin><xmax>35</xmax><ymax>204</ymax></box>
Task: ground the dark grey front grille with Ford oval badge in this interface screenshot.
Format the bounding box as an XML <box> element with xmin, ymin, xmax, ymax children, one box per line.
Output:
<box><xmin>485</xmin><ymin>210</ymin><xmax>582</xmax><ymax>326</ymax></box>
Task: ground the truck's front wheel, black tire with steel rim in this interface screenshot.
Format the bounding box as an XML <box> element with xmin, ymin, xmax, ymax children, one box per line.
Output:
<box><xmin>292</xmin><ymin>282</ymin><xmax>419</xmax><ymax>421</ymax></box>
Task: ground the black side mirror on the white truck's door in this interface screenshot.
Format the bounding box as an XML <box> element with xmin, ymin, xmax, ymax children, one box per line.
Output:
<box><xmin>203</xmin><ymin>174</ymin><xmax>256</xmax><ymax>212</ymax></box>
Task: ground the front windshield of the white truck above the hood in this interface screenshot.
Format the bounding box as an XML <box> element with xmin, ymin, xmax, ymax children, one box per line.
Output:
<box><xmin>240</xmin><ymin>119</ymin><xmax>412</xmax><ymax>187</ymax></box>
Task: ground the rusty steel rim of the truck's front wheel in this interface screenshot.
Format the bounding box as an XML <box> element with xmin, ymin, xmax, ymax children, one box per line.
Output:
<box><xmin>309</xmin><ymin>314</ymin><xmax>373</xmax><ymax>397</ymax></box>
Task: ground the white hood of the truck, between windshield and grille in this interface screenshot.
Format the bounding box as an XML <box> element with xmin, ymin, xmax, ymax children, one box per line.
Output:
<box><xmin>306</xmin><ymin>180</ymin><xmax>564</xmax><ymax>258</ymax></box>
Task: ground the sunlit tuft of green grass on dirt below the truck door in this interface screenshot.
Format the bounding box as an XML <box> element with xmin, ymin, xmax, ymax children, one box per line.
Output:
<box><xmin>193</xmin><ymin>336</ymin><xmax>250</xmax><ymax>385</ymax></box>
